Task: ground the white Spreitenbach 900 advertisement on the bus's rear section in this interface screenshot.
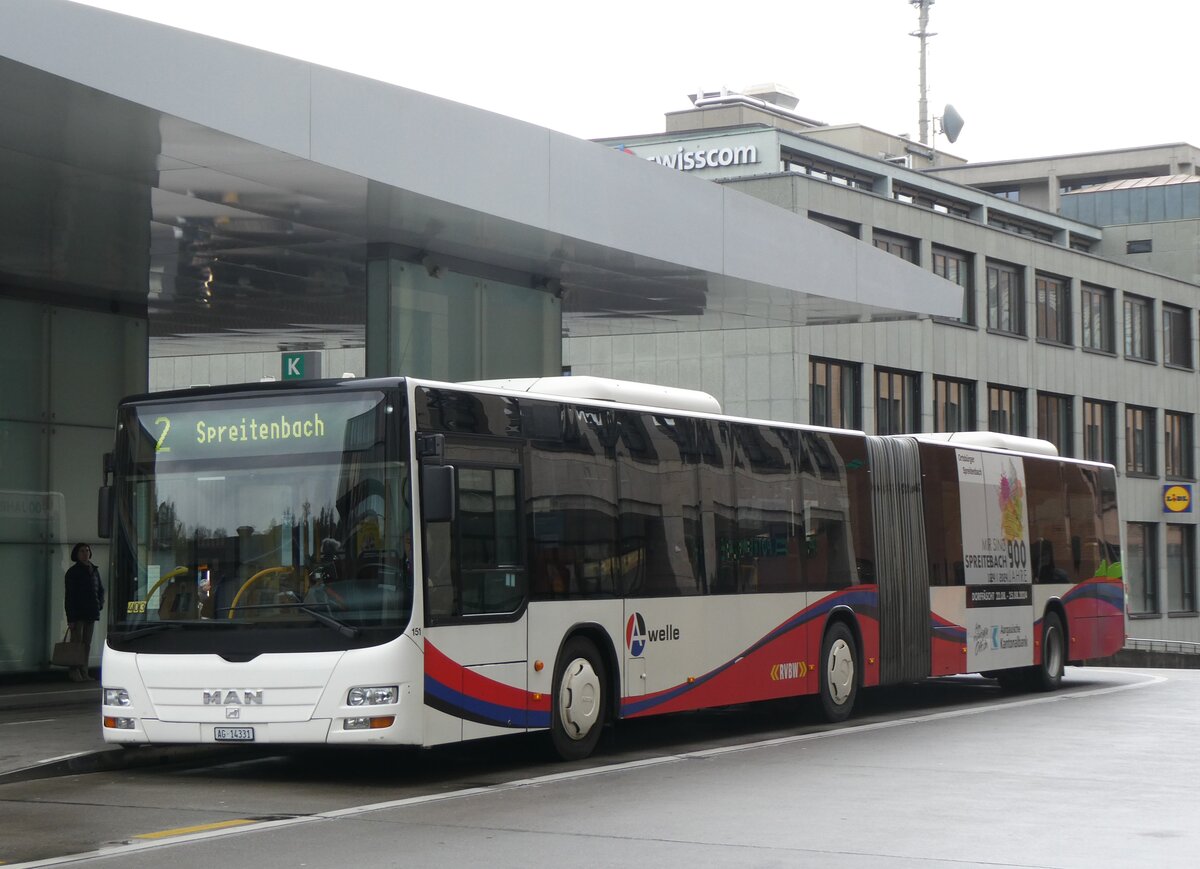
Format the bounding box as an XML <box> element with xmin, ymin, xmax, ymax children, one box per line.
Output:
<box><xmin>955</xmin><ymin>450</ymin><xmax>1033</xmax><ymax>671</ymax></box>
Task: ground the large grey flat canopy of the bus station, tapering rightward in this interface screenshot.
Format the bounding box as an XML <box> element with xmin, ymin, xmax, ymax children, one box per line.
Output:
<box><xmin>0</xmin><ymin>0</ymin><xmax>961</xmax><ymax>352</ymax></box>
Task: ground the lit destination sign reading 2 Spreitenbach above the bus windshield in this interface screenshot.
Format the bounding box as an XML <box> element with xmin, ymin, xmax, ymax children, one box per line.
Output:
<box><xmin>137</xmin><ymin>392</ymin><xmax>383</xmax><ymax>463</ymax></box>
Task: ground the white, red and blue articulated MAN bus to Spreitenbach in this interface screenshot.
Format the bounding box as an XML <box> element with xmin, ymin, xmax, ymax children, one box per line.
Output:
<box><xmin>100</xmin><ymin>377</ymin><xmax>1124</xmax><ymax>759</ymax></box>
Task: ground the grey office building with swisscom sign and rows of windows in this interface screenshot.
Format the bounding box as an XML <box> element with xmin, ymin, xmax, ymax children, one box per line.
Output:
<box><xmin>583</xmin><ymin>88</ymin><xmax>1200</xmax><ymax>643</ymax></box>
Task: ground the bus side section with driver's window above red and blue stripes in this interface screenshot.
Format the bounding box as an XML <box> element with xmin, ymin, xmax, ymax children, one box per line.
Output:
<box><xmin>421</xmin><ymin>443</ymin><xmax>528</xmax><ymax>744</ymax></box>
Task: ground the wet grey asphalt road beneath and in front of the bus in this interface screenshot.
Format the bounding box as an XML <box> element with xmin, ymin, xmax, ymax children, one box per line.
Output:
<box><xmin>0</xmin><ymin>669</ymin><xmax>1200</xmax><ymax>869</ymax></box>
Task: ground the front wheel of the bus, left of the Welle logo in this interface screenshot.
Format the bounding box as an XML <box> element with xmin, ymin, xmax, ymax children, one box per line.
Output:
<box><xmin>550</xmin><ymin>636</ymin><xmax>608</xmax><ymax>761</ymax></box>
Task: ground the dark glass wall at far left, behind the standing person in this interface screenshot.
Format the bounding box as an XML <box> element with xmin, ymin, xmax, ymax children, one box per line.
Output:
<box><xmin>0</xmin><ymin>300</ymin><xmax>146</xmax><ymax>672</ymax></box>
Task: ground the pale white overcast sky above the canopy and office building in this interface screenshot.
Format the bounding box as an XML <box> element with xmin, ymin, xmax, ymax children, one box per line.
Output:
<box><xmin>80</xmin><ymin>0</ymin><xmax>1200</xmax><ymax>161</ymax></box>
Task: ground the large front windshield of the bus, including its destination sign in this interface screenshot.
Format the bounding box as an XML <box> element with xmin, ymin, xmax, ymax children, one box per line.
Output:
<box><xmin>109</xmin><ymin>390</ymin><xmax>413</xmax><ymax>652</ymax></box>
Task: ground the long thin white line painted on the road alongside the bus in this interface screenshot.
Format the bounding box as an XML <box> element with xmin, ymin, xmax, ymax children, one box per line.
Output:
<box><xmin>5</xmin><ymin>673</ymin><xmax>1168</xmax><ymax>869</ymax></box>
